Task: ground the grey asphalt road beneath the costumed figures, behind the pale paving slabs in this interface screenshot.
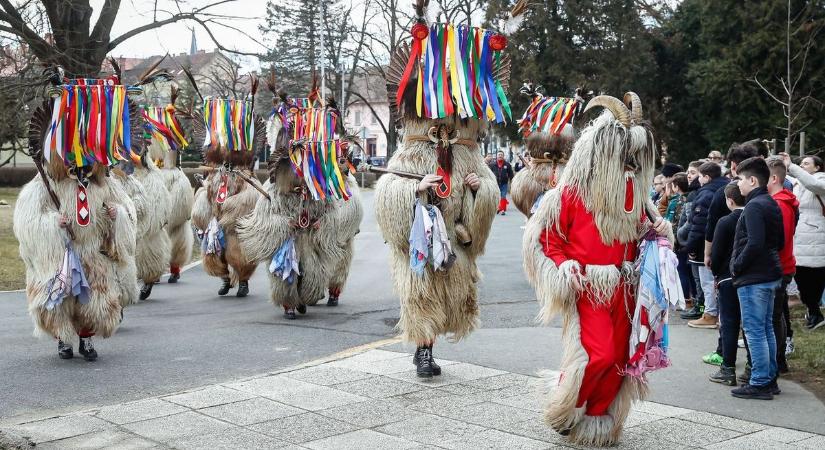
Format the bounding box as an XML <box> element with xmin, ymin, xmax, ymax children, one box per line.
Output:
<box><xmin>0</xmin><ymin>191</ymin><xmax>535</xmax><ymax>417</ymax></box>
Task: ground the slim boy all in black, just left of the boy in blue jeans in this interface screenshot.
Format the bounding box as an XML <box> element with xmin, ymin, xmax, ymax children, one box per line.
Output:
<box><xmin>710</xmin><ymin>181</ymin><xmax>745</xmax><ymax>386</ymax></box>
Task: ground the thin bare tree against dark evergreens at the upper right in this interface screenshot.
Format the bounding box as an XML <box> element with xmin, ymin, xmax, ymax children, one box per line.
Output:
<box><xmin>753</xmin><ymin>0</ymin><xmax>825</xmax><ymax>153</ymax></box>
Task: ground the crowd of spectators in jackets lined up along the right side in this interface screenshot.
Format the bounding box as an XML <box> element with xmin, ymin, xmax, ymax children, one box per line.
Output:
<box><xmin>651</xmin><ymin>140</ymin><xmax>825</xmax><ymax>400</ymax></box>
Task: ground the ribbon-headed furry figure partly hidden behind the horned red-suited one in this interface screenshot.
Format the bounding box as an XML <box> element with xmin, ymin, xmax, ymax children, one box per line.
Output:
<box><xmin>510</xmin><ymin>83</ymin><xmax>584</xmax><ymax>218</ymax></box>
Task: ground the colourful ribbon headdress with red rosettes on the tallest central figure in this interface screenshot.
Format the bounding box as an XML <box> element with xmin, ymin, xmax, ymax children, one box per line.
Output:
<box><xmin>387</xmin><ymin>0</ymin><xmax>526</xmax><ymax>123</ymax></box>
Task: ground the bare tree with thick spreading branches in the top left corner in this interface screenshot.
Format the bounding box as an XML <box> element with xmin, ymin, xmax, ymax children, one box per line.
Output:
<box><xmin>0</xmin><ymin>0</ymin><xmax>254</xmax><ymax>76</ymax></box>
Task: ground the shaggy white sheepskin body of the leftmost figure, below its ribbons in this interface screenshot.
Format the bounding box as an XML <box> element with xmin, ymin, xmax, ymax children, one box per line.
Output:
<box><xmin>14</xmin><ymin>102</ymin><xmax>137</xmax><ymax>346</ymax></box>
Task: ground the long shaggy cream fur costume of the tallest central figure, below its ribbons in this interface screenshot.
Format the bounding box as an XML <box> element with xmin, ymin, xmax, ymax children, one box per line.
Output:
<box><xmin>375</xmin><ymin>118</ymin><xmax>499</xmax><ymax>344</ymax></box>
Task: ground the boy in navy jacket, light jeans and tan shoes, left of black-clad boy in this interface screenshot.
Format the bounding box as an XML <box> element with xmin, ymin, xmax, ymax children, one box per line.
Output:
<box><xmin>688</xmin><ymin>162</ymin><xmax>729</xmax><ymax>330</ymax></box>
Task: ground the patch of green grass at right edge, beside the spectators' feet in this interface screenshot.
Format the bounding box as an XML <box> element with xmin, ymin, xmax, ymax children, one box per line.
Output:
<box><xmin>783</xmin><ymin>305</ymin><xmax>825</xmax><ymax>402</ymax></box>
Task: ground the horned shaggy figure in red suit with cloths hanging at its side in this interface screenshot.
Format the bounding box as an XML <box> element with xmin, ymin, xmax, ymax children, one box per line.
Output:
<box><xmin>523</xmin><ymin>93</ymin><xmax>678</xmax><ymax>446</ymax></box>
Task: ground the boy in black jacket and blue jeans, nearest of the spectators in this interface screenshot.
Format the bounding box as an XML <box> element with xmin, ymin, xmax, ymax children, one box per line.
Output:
<box><xmin>730</xmin><ymin>157</ymin><xmax>785</xmax><ymax>400</ymax></box>
